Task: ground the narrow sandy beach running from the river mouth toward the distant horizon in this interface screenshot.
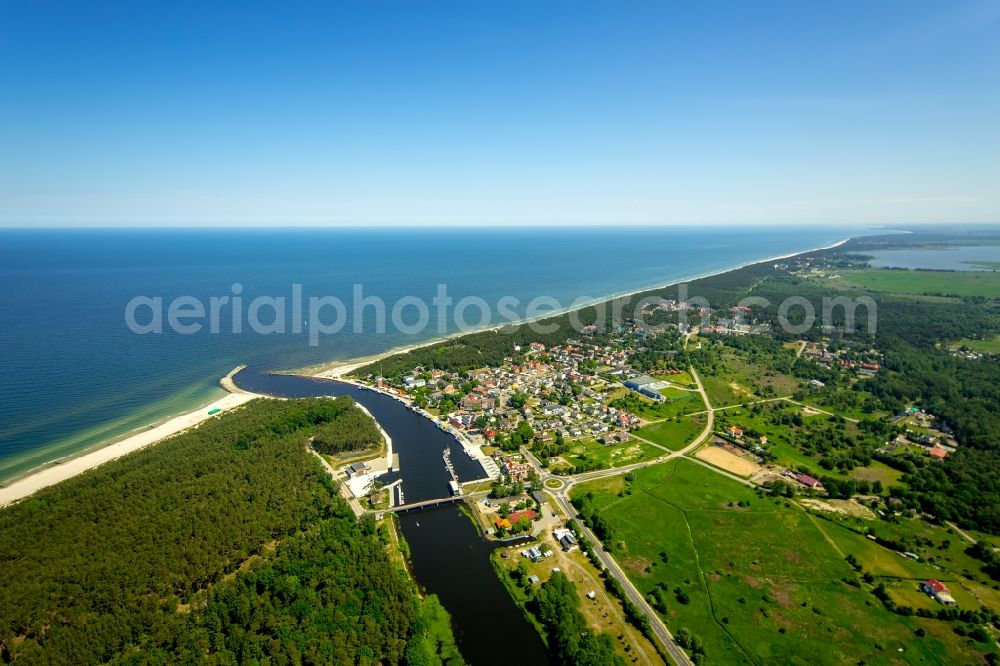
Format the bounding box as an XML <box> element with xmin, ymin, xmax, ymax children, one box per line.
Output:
<box><xmin>304</xmin><ymin>236</ymin><xmax>856</xmax><ymax>379</ymax></box>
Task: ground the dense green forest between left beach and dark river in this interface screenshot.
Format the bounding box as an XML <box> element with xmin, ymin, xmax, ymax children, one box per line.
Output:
<box><xmin>0</xmin><ymin>398</ymin><xmax>461</xmax><ymax>664</ymax></box>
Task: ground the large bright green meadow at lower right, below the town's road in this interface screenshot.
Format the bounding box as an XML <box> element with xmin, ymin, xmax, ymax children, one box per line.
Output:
<box><xmin>574</xmin><ymin>460</ymin><xmax>986</xmax><ymax>664</ymax></box>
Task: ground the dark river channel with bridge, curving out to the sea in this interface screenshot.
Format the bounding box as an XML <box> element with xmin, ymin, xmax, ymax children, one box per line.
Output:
<box><xmin>233</xmin><ymin>368</ymin><xmax>549</xmax><ymax>666</ymax></box>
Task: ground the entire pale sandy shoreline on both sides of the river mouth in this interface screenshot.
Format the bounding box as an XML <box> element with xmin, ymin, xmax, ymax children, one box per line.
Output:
<box><xmin>0</xmin><ymin>237</ymin><xmax>855</xmax><ymax>509</ymax></box>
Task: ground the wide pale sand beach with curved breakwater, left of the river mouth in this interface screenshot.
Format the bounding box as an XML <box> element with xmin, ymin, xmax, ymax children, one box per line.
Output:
<box><xmin>0</xmin><ymin>365</ymin><xmax>260</xmax><ymax>507</ymax></box>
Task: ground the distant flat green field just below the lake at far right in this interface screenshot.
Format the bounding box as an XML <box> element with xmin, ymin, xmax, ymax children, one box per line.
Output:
<box><xmin>839</xmin><ymin>268</ymin><xmax>1000</xmax><ymax>298</ymax></box>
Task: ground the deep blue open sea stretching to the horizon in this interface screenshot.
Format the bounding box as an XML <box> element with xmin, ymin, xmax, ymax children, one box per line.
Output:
<box><xmin>0</xmin><ymin>227</ymin><xmax>864</xmax><ymax>480</ymax></box>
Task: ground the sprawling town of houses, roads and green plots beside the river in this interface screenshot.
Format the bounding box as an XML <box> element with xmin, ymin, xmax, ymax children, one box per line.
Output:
<box><xmin>318</xmin><ymin>249</ymin><xmax>1000</xmax><ymax>663</ymax></box>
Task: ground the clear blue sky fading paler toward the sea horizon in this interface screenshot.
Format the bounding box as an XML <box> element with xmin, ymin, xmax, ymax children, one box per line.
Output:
<box><xmin>0</xmin><ymin>0</ymin><xmax>1000</xmax><ymax>226</ymax></box>
